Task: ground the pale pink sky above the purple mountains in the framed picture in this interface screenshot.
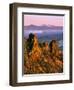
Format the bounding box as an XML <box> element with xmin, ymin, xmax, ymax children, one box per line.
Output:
<box><xmin>24</xmin><ymin>15</ymin><xmax>64</xmax><ymax>26</ymax></box>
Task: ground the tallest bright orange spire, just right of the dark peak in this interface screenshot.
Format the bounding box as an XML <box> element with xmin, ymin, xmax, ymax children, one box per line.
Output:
<box><xmin>26</xmin><ymin>34</ymin><xmax>41</xmax><ymax>61</ymax></box>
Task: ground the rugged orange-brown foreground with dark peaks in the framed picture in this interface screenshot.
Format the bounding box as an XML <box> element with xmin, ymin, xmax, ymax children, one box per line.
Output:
<box><xmin>24</xmin><ymin>34</ymin><xmax>63</xmax><ymax>74</ymax></box>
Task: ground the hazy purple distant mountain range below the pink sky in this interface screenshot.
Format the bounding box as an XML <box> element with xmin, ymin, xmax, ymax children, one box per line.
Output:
<box><xmin>24</xmin><ymin>25</ymin><xmax>63</xmax><ymax>30</ymax></box>
